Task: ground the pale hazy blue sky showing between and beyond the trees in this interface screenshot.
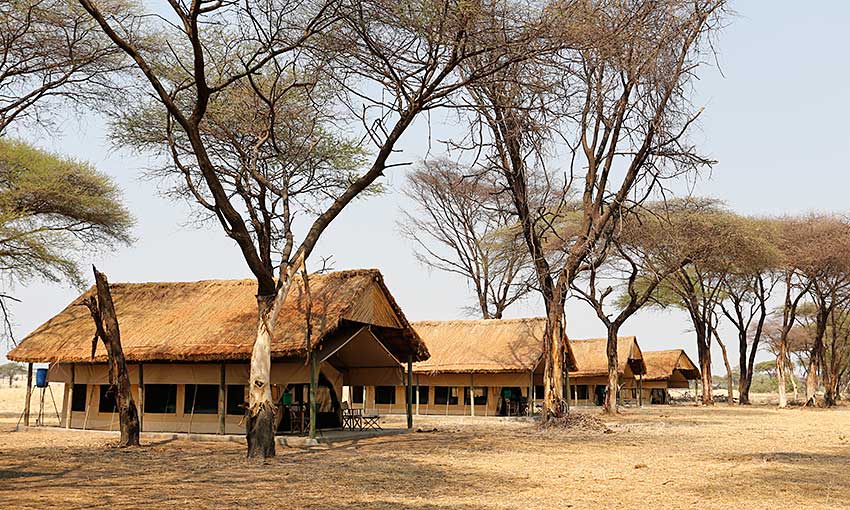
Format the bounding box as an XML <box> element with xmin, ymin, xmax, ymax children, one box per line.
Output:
<box><xmin>1</xmin><ymin>0</ymin><xmax>850</xmax><ymax>373</ymax></box>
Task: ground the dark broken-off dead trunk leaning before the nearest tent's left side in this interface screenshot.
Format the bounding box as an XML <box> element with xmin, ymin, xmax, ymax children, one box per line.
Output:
<box><xmin>87</xmin><ymin>267</ymin><xmax>140</xmax><ymax>447</ymax></box>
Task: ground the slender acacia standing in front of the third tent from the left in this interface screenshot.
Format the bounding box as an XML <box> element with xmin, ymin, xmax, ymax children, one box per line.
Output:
<box><xmin>572</xmin><ymin>210</ymin><xmax>686</xmax><ymax>414</ymax></box>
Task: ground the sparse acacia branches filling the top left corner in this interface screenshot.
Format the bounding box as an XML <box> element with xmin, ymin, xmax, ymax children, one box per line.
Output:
<box><xmin>0</xmin><ymin>0</ymin><xmax>129</xmax><ymax>136</ymax></box>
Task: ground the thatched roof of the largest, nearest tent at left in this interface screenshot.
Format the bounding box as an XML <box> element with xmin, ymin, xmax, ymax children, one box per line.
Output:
<box><xmin>7</xmin><ymin>269</ymin><xmax>428</xmax><ymax>363</ymax></box>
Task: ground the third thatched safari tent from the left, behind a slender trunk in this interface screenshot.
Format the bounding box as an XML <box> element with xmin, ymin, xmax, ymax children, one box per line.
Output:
<box><xmin>570</xmin><ymin>336</ymin><xmax>646</xmax><ymax>405</ymax></box>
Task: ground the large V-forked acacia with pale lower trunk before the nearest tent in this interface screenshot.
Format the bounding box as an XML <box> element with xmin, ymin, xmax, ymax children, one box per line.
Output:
<box><xmin>86</xmin><ymin>0</ymin><xmax>556</xmax><ymax>457</ymax></box>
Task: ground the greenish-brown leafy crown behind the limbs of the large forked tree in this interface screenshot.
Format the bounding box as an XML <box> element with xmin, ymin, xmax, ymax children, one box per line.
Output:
<box><xmin>112</xmin><ymin>71</ymin><xmax>368</xmax><ymax>239</ymax></box>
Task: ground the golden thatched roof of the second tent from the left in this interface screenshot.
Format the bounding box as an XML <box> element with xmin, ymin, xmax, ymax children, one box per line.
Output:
<box><xmin>413</xmin><ymin>318</ymin><xmax>575</xmax><ymax>373</ymax></box>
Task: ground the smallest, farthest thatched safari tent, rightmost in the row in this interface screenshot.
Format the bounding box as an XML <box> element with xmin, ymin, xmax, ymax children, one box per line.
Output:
<box><xmin>643</xmin><ymin>349</ymin><xmax>700</xmax><ymax>404</ymax></box>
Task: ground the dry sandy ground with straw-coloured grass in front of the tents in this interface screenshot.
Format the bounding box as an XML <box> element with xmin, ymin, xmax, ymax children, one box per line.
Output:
<box><xmin>0</xmin><ymin>389</ymin><xmax>850</xmax><ymax>510</ymax></box>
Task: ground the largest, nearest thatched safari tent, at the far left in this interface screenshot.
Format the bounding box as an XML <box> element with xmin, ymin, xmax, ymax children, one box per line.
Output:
<box><xmin>8</xmin><ymin>270</ymin><xmax>428</xmax><ymax>434</ymax></box>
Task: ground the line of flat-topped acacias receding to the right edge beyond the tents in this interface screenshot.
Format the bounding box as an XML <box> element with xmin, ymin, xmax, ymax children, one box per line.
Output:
<box><xmin>406</xmin><ymin>179</ymin><xmax>850</xmax><ymax>412</ymax></box>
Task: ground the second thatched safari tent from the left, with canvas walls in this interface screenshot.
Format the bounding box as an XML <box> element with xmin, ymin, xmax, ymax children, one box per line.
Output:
<box><xmin>352</xmin><ymin>318</ymin><xmax>575</xmax><ymax>416</ymax></box>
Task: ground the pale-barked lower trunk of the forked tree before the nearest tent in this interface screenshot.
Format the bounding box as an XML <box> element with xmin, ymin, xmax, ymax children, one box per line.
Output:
<box><xmin>245</xmin><ymin>296</ymin><xmax>275</xmax><ymax>458</ymax></box>
